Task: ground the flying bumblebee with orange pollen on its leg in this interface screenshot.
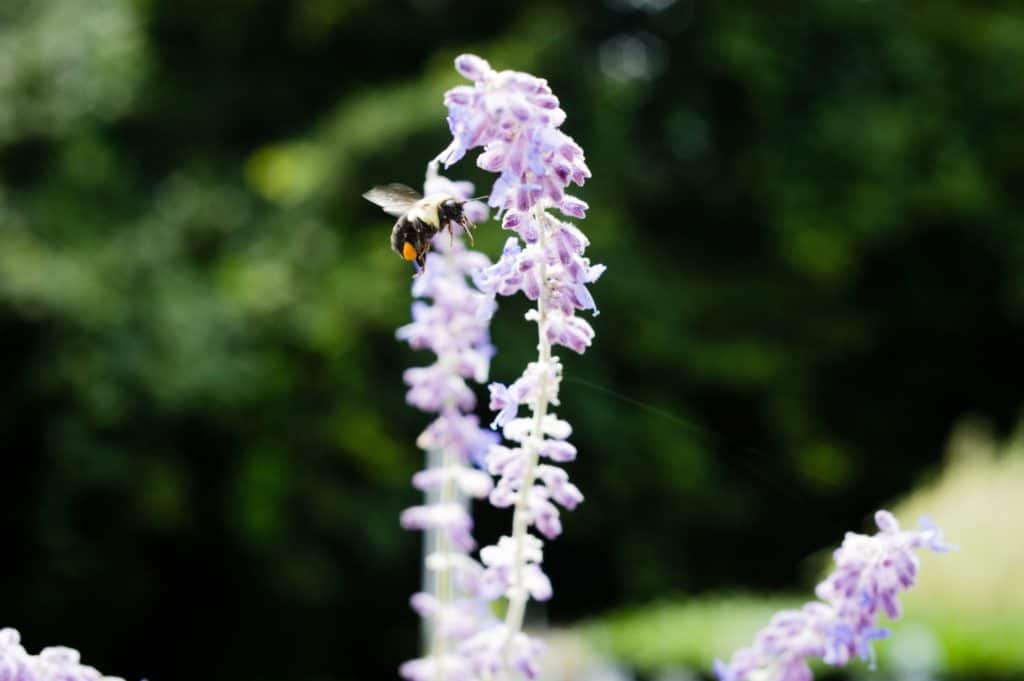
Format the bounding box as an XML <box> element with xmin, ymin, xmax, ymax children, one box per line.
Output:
<box><xmin>362</xmin><ymin>182</ymin><xmax>474</xmax><ymax>276</ymax></box>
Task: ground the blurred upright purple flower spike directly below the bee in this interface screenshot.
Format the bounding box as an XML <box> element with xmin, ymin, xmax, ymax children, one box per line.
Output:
<box><xmin>395</xmin><ymin>164</ymin><xmax>498</xmax><ymax>681</ymax></box>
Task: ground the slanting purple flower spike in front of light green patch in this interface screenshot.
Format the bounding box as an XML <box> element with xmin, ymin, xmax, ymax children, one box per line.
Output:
<box><xmin>715</xmin><ymin>511</ymin><xmax>954</xmax><ymax>681</ymax></box>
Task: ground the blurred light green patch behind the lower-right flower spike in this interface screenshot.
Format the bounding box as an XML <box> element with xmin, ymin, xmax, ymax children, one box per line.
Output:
<box><xmin>554</xmin><ymin>422</ymin><xmax>1024</xmax><ymax>679</ymax></box>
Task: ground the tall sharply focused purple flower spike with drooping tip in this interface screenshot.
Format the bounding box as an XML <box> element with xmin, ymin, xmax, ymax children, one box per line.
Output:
<box><xmin>438</xmin><ymin>54</ymin><xmax>604</xmax><ymax>679</ymax></box>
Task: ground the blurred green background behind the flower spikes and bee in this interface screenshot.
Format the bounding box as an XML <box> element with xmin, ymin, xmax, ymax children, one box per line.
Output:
<box><xmin>0</xmin><ymin>0</ymin><xmax>1024</xmax><ymax>681</ymax></box>
